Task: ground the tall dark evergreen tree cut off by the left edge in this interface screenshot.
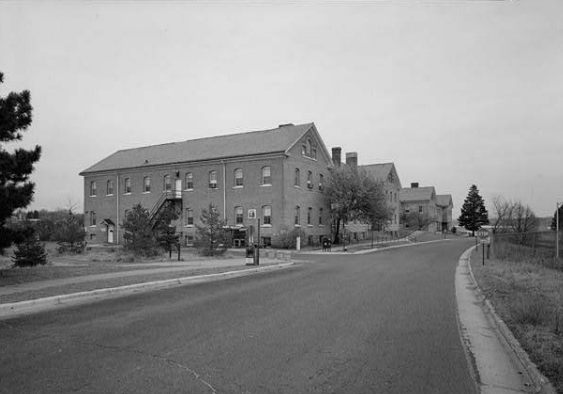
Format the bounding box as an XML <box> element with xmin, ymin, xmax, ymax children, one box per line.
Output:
<box><xmin>0</xmin><ymin>72</ymin><xmax>41</xmax><ymax>252</ymax></box>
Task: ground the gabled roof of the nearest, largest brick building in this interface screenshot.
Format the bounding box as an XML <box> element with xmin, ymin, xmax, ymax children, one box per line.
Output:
<box><xmin>80</xmin><ymin>123</ymin><xmax>330</xmax><ymax>175</ymax></box>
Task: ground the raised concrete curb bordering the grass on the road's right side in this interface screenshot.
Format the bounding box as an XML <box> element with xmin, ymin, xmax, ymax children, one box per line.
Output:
<box><xmin>467</xmin><ymin>246</ymin><xmax>557</xmax><ymax>394</ymax></box>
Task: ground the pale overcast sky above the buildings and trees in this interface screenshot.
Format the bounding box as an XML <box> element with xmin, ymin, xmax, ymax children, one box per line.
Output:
<box><xmin>0</xmin><ymin>0</ymin><xmax>563</xmax><ymax>217</ymax></box>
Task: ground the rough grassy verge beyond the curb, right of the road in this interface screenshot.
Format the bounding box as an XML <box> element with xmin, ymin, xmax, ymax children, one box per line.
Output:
<box><xmin>471</xmin><ymin>252</ymin><xmax>563</xmax><ymax>393</ymax></box>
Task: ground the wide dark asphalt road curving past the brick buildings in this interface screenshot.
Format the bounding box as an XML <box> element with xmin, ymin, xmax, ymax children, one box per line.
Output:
<box><xmin>0</xmin><ymin>241</ymin><xmax>477</xmax><ymax>394</ymax></box>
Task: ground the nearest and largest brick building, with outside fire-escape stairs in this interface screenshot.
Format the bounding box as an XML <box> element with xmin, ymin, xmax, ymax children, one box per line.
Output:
<box><xmin>80</xmin><ymin>123</ymin><xmax>331</xmax><ymax>246</ymax></box>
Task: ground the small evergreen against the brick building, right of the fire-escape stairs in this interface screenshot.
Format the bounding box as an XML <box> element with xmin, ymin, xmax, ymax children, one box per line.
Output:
<box><xmin>194</xmin><ymin>204</ymin><xmax>229</xmax><ymax>256</ymax></box>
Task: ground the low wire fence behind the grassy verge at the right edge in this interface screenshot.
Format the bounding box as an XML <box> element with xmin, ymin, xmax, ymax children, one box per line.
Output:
<box><xmin>491</xmin><ymin>231</ymin><xmax>563</xmax><ymax>269</ymax></box>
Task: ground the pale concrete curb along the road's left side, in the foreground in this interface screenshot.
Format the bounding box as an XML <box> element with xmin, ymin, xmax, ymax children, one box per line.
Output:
<box><xmin>0</xmin><ymin>262</ymin><xmax>295</xmax><ymax>320</ymax></box>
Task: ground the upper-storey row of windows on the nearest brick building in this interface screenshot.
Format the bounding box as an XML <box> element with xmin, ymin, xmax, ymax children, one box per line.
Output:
<box><xmin>90</xmin><ymin>166</ymin><xmax>324</xmax><ymax>197</ymax></box>
